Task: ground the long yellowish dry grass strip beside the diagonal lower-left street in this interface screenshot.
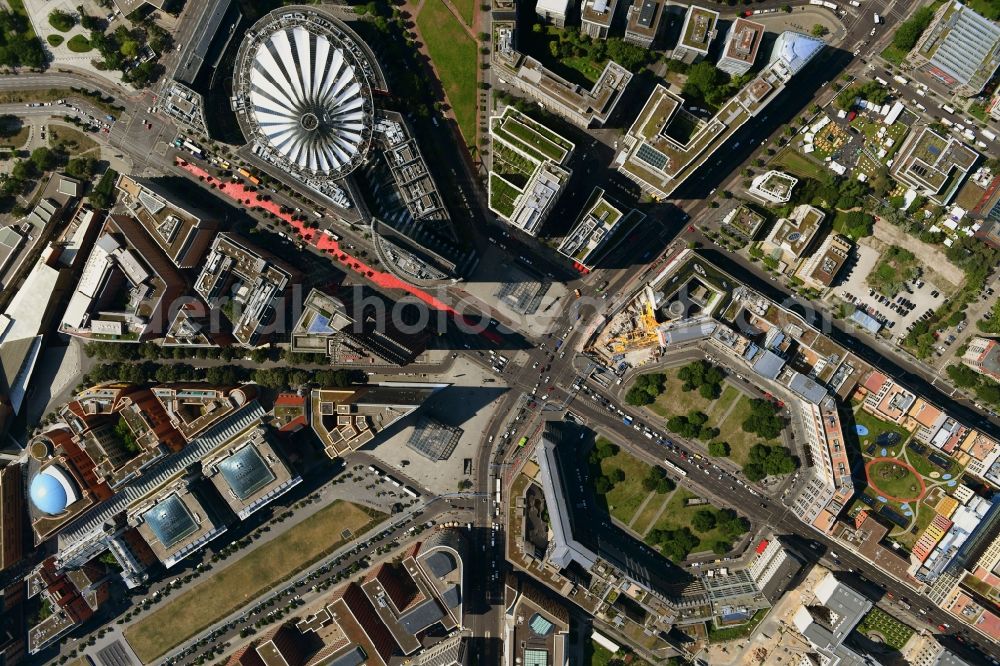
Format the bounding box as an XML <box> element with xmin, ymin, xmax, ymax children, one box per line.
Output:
<box><xmin>125</xmin><ymin>501</ymin><xmax>385</xmax><ymax>663</ymax></box>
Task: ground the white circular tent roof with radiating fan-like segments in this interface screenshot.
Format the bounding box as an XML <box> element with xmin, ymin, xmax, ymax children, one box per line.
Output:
<box><xmin>237</xmin><ymin>15</ymin><xmax>373</xmax><ymax>177</ymax></box>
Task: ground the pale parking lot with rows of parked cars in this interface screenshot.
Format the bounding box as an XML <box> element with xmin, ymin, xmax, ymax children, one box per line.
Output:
<box><xmin>834</xmin><ymin>245</ymin><xmax>946</xmax><ymax>338</ymax></box>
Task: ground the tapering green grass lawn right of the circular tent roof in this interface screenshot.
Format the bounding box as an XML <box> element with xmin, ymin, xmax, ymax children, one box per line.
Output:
<box><xmin>417</xmin><ymin>0</ymin><xmax>479</xmax><ymax>146</ymax></box>
